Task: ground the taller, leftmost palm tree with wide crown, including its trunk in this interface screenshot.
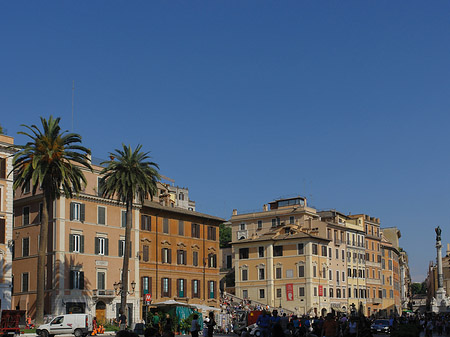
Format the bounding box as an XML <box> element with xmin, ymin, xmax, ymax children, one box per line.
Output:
<box><xmin>11</xmin><ymin>116</ymin><xmax>92</xmax><ymax>324</ymax></box>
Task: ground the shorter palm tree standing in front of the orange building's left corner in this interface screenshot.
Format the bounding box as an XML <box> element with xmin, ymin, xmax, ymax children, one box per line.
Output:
<box><xmin>100</xmin><ymin>144</ymin><xmax>160</xmax><ymax>314</ymax></box>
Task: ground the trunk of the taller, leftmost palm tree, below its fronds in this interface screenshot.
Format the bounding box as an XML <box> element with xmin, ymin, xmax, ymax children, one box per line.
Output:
<box><xmin>36</xmin><ymin>192</ymin><xmax>50</xmax><ymax>326</ymax></box>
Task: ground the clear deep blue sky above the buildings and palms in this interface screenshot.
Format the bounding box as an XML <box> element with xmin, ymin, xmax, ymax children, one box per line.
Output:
<box><xmin>0</xmin><ymin>0</ymin><xmax>450</xmax><ymax>281</ymax></box>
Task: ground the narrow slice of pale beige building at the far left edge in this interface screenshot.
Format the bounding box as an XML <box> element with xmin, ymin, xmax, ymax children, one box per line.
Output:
<box><xmin>0</xmin><ymin>135</ymin><xmax>14</xmax><ymax>310</ymax></box>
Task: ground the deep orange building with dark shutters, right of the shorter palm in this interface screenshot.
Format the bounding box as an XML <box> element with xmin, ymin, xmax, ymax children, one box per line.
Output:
<box><xmin>139</xmin><ymin>200</ymin><xmax>221</xmax><ymax>318</ymax></box>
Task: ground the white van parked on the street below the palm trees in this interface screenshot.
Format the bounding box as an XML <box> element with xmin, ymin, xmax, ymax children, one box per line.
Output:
<box><xmin>36</xmin><ymin>314</ymin><xmax>93</xmax><ymax>337</ymax></box>
